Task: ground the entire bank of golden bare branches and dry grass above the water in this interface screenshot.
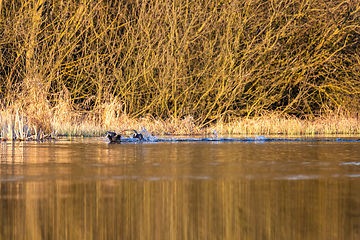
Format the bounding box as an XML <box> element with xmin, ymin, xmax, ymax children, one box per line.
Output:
<box><xmin>0</xmin><ymin>0</ymin><xmax>360</xmax><ymax>136</ymax></box>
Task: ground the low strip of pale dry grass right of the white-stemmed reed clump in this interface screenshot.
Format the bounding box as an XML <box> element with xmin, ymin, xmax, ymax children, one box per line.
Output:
<box><xmin>49</xmin><ymin>111</ymin><xmax>360</xmax><ymax>136</ymax></box>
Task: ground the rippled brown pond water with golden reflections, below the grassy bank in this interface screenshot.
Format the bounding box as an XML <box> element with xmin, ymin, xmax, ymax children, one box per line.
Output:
<box><xmin>0</xmin><ymin>138</ymin><xmax>360</xmax><ymax>239</ymax></box>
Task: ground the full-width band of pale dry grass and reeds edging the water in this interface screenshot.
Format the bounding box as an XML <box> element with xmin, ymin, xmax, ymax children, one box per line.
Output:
<box><xmin>0</xmin><ymin>110</ymin><xmax>360</xmax><ymax>140</ymax></box>
